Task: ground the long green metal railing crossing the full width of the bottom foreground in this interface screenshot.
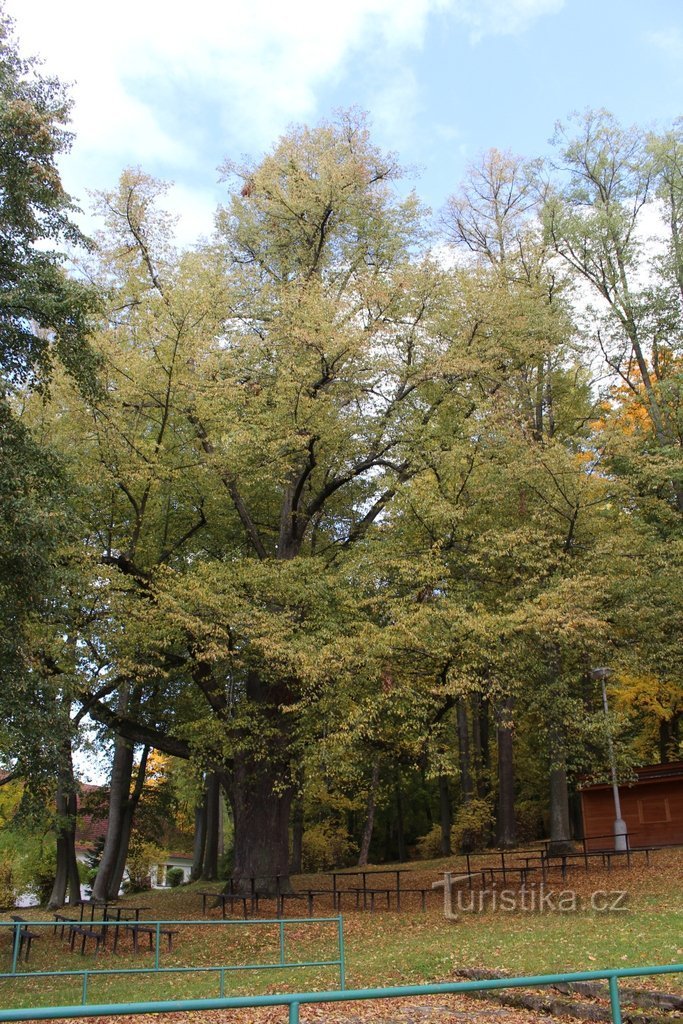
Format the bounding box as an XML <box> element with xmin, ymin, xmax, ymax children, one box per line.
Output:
<box><xmin>0</xmin><ymin>958</ymin><xmax>683</xmax><ymax>1024</ymax></box>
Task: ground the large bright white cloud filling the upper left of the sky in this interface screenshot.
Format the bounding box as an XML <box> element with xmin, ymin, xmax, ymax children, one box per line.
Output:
<box><xmin>6</xmin><ymin>0</ymin><xmax>563</xmax><ymax>241</ymax></box>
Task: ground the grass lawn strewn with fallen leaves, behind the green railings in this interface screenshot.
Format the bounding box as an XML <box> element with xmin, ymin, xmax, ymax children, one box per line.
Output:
<box><xmin>0</xmin><ymin>850</ymin><xmax>683</xmax><ymax>1024</ymax></box>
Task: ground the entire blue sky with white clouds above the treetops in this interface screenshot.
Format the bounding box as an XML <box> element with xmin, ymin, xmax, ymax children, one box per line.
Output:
<box><xmin>5</xmin><ymin>0</ymin><xmax>683</xmax><ymax>242</ymax></box>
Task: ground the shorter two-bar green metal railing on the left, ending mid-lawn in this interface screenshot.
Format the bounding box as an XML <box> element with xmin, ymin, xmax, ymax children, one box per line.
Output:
<box><xmin>0</xmin><ymin>914</ymin><xmax>345</xmax><ymax>1003</ymax></box>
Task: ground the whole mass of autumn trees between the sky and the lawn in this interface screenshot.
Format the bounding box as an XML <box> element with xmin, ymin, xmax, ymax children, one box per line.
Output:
<box><xmin>0</xmin><ymin>6</ymin><xmax>683</xmax><ymax>905</ymax></box>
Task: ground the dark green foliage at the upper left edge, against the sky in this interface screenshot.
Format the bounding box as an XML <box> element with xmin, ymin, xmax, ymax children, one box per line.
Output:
<box><xmin>0</xmin><ymin>10</ymin><xmax>95</xmax><ymax>393</ymax></box>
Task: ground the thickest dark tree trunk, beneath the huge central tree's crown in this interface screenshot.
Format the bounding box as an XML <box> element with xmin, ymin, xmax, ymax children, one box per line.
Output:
<box><xmin>229</xmin><ymin>752</ymin><xmax>294</xmax><ymax>895</ymax></box>
